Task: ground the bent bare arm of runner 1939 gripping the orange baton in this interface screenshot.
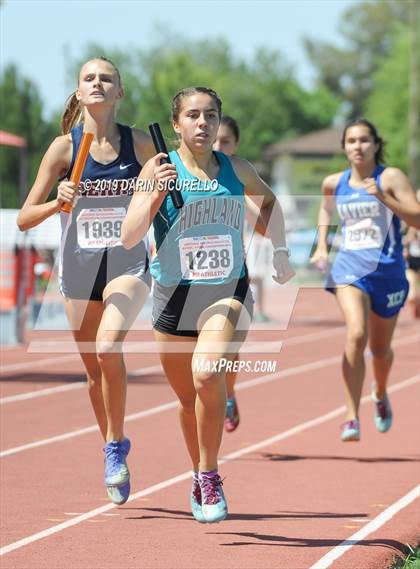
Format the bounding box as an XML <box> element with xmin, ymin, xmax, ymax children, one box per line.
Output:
<box><xmin>17</xmin><ymin>135</ymin><xmax>72</xmax><ymax>231</ymax></box>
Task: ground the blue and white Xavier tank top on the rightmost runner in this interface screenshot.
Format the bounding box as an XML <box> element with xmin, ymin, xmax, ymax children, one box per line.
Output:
<box><xmin>331</xmin><ymin>165</ymin><xmax>405</xmax><ymax>284</ymax></box>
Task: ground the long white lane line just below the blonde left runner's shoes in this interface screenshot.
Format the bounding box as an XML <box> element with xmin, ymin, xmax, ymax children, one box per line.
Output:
<box><xmin>0</xmin><ymin>370</ymin><xmax>420</xmax><ymax>556</ymax></box>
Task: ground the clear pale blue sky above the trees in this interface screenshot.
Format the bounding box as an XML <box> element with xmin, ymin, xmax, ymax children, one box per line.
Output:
<box><xmin>0</xmin><ymin>0</ymin><xmax>358</xmax><ymax>117</ymax></box>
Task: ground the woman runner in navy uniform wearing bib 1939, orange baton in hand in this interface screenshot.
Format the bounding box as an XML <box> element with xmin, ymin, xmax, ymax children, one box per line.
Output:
<box><xmin>18</xmin><ymin>58</ymin><xmax>154</xmax><ymax>504</ymax></box>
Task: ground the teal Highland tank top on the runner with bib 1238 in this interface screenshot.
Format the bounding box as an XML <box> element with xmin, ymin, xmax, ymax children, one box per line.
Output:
<box><xmin>151</xmin><ymin>151</ymin><xmax>246</xmax><ymax>286</ymax></box>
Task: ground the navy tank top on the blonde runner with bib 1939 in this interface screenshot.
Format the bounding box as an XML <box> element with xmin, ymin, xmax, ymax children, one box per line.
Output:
<box><xmin>60</xmin><ymin>124</ymin><xmax>146</xmax><ymax>274</ymax></box>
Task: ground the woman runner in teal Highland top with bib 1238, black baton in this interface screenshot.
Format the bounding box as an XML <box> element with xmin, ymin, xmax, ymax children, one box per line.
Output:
<box><xmin>121</xmin><ymin>87</ymin><xmax>293</xmax><ymax>522</ymax></box>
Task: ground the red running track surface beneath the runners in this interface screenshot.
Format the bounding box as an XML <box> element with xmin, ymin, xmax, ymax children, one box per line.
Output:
<box><xmin>0</xmin><ymin>289</ymin><xmax>420</xmax><ymax>569</ymax></box>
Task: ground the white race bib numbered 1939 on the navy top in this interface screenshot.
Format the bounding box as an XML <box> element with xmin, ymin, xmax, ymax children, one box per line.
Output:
<box><xmin>77</xmin><ymin>207</ymin><xmax>126</xmax><ymax>249</ymax></box>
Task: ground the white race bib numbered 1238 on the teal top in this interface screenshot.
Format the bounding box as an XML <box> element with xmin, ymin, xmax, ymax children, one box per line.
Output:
<box><xmin>179</xmin><ymin>235</ymin><xmax>233</xmax><ymax>280</ymax></box>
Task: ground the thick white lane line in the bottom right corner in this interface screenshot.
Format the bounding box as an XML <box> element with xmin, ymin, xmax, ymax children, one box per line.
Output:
<box><xmin>309</xmin><ymin>485</ymin><xmax>420</xmax><ymax>569</ymax></box>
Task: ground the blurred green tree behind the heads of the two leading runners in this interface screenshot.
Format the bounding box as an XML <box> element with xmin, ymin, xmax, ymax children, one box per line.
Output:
<box><xmin>68</xmin><ymin>30</ymin><xmax>339</xmax><ymax>161</ymax></box>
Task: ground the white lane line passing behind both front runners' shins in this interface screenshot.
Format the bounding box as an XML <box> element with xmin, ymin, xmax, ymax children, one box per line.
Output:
<box><xmin>0</xmin><ymin>334</ymin><xmax>417</xmax><ymax>458</ymax></box>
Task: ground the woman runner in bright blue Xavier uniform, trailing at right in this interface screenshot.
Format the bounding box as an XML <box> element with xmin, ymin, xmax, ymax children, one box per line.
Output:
<box><xmin>311</xmin><ymin>119</ymin><xmax>420</xmax><ymax>441</ymax></box>
